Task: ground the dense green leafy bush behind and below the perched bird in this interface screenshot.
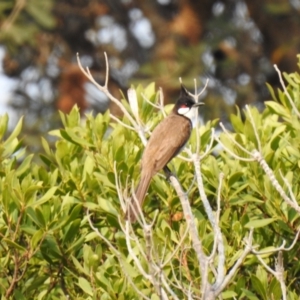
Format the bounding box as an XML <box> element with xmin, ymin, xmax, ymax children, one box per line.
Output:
<box><xmin>0</xmin><ymin>57</ymin><xmax>300</xmax><ymax>299</ymax></box>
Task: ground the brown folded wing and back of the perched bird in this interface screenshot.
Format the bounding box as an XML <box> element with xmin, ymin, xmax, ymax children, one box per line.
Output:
<box><xmin>142</xmin><ymin>115</ymin><xmax>192</xmax><ymax>176</ymax></box>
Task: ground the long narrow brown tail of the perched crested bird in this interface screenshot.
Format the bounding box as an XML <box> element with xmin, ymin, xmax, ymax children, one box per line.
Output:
<box><xmin>126</xmin><ymin>174</ymin><xmax>152</xmax><ymax>223</ymax></box>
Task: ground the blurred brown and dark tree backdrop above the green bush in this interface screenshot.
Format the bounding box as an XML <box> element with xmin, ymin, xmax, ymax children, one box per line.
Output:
<box><xmin>0</xmin><ymin>0</ymin><xmax>300</xmax><ymax>150</ymax></box>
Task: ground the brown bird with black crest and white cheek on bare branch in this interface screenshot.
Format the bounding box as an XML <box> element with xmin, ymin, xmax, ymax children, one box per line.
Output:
<box><xmin>126</xmin><ymin>84</ymin><xmax>204</xmax><ymax>223</ymax></box>
